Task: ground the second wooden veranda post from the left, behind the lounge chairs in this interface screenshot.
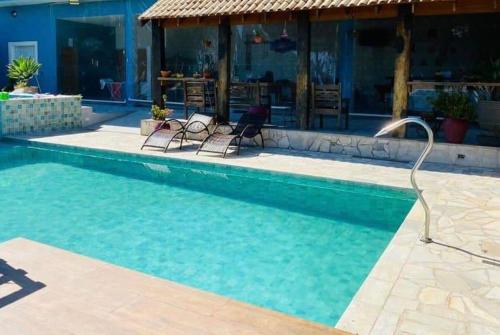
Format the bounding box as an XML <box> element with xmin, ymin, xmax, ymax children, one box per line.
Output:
<box><xmin>217</xmin><ymin>17</ymin><xmax>231</xmax><ymax>121</ymax></box>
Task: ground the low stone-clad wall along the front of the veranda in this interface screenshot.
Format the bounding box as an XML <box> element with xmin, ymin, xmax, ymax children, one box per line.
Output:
<box><xmin>141</xmin><ymin>120</ymin><xmax>500</xmax><ymax>169</ymax></box>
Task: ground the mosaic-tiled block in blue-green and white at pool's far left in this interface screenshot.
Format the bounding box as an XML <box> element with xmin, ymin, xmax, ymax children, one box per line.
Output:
<box><xmin>0</xmin><ymin>95</ymin><xmax>82</xmax><ymax>136</ymax></box>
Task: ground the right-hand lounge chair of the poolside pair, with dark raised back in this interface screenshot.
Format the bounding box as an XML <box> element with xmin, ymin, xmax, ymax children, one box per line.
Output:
<box><xmin>196</xmin><ymin>112</ymin><xmax>267</xmax><ymax>157</ymax></box>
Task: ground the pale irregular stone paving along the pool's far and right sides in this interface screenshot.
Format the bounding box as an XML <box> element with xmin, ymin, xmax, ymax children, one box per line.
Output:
<box><xmin>6</xmin><ymin>113</ymin><xmax>500</xmax><ymax>335</ymax></box>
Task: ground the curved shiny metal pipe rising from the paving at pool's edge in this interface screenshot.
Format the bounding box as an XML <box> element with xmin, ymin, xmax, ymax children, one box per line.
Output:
<box><xmin>374</xmin><ymin>117</ymin><xmax>434</xmax><ymax>243</ymax></box>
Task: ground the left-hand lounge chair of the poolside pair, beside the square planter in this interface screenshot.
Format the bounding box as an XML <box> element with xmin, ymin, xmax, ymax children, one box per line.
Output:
<box><xmin>141</xmin><ymin>113</ymin><xmax>214</xmax><ymax>152</ymax></box>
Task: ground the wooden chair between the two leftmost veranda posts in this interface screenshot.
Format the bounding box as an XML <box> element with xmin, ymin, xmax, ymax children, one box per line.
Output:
<box><xmin>184</xmin><ymin>80</ymin><xmax>216</xmax><ymax>119</ymax></box>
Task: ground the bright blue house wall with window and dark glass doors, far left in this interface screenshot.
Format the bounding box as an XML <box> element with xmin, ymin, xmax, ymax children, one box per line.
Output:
<box><xmin>0</xmin><ymin>0</ymin><xmax>154</xmax><ymax>102</ymax></box>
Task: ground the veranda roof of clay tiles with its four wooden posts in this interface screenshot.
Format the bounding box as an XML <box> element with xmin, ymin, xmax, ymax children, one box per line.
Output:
<box><xmin>140</xmin><ymin>0</ymin><xmax>500</xmax><ymax>136</ymax></box>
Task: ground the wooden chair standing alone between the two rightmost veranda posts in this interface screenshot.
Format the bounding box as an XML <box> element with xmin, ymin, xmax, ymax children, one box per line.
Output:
<box><xmin>311</xmin><ymin>83</ymin><xmax>349</xmax><ymax>129</ymax></box>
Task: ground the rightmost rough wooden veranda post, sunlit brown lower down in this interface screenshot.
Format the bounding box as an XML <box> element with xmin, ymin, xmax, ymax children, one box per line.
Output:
<box><xmin>392</xmin><ymin>5</ymin><xmax>412</xmax><ymax>137</ymax></box>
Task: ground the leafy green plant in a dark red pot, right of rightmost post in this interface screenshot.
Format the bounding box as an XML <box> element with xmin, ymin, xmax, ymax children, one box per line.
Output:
<box><xmin>431</xmin><ymin>91</ymin><xmax>476</xmax><ymax>143</ymax></box>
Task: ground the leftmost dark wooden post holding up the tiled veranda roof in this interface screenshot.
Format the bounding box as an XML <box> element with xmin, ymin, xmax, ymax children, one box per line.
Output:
<box><xmin>151</xmin><ymin>20</ymin><xmax>165</xmax><ymax>108</ymax></box>
